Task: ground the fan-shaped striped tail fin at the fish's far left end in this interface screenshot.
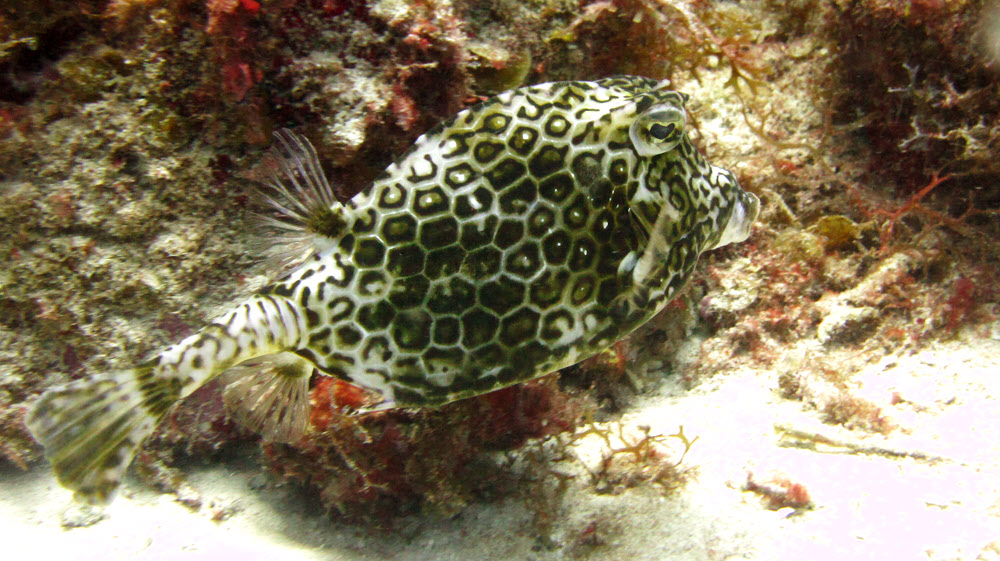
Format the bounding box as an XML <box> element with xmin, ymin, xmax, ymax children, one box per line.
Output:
<box><xmin>25</xmin><ymin>365</ymin><xmax>169</xmax><ymax>505</ymax></box>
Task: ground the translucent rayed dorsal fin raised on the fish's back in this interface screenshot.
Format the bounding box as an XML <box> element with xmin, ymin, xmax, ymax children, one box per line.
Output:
<box><xmin>254</xmin><ymin>129</ymin><xmax>347</xmax><ymax>276</ymax></box>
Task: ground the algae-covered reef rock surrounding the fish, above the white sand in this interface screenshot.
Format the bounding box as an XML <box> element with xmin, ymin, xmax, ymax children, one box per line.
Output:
<box><xmin>0</xmin><ymin>0</ymin><xmax>1000</xmax><ymax>548</ymax></box>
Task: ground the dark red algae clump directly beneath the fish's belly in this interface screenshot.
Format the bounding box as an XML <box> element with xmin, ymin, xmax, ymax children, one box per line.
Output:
<box><xmin>265</xmin><ymin>377</ymin><xmax>581</xmax><ymax>524</ymax></box>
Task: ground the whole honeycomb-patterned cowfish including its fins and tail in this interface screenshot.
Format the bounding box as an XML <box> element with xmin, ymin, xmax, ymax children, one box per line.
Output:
<box><xmin>26</xmin><ymin>76</ymin><xmax>760</xmax><ymax>504</ymax></box>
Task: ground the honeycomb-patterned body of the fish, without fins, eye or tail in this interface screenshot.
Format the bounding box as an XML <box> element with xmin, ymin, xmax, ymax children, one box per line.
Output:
<box><xmin>263</xmin><ymin>78</ymin><xmax>756</xmax><ymax>405</ymax></box>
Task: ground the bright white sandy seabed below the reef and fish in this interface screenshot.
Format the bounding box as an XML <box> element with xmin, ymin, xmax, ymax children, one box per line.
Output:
<box><xmin>0</xmin><ymin>334</ymin><xmax>1000</xmax><ymax>561</ymax></box>
